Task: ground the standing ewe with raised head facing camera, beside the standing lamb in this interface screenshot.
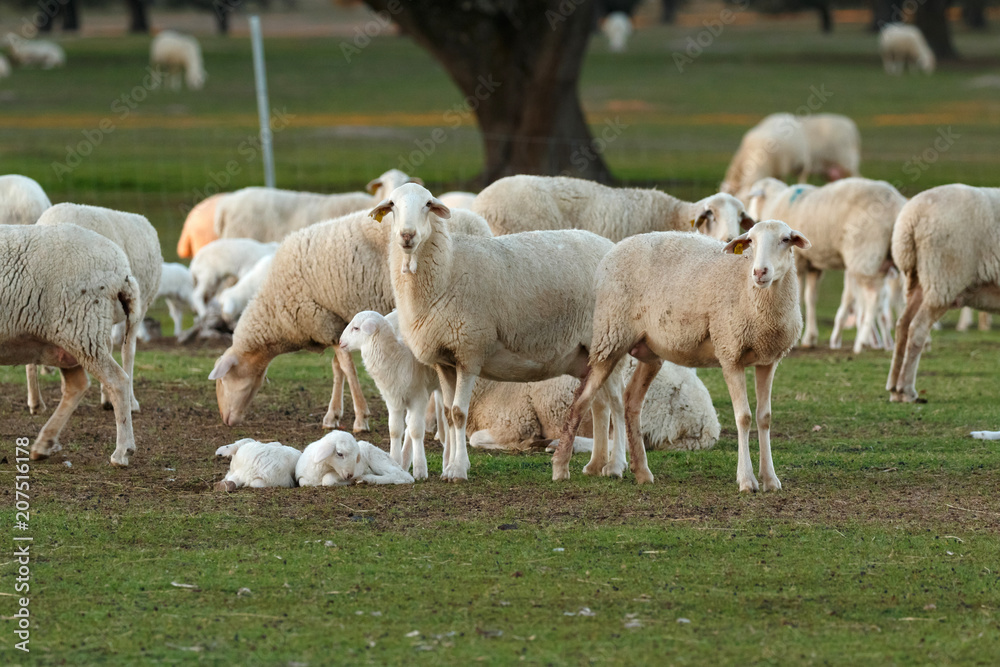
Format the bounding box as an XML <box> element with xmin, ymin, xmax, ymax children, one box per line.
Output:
<box><xmin>370</xmin><ymin>183</ymin><xmax>625</xmax><ymax>481</ymax></box>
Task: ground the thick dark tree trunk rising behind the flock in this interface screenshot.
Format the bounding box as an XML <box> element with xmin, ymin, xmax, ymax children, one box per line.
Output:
<box><xmin>356</xmin><ymin>0</ymin><xmax>621</xmax><ymax>185</ymax></box>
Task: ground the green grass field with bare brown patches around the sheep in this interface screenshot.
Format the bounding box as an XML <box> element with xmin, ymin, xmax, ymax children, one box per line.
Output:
<box><xmin>0</xmin><ymin>7</ymin><xmax>1000</xmax><ymax>665</ymax></box>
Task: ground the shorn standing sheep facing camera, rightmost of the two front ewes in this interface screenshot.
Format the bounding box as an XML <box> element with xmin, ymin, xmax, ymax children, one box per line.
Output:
<box><xmin>552</xmin><ymin>220</ymin><xmax>810</xmax><ymax>492</ymax></box>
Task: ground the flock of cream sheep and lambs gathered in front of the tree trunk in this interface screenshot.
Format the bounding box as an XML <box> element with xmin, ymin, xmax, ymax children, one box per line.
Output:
<box><xmin>0</xmin><ymin>103</ymin><xmax>1000</xmax><ymax>491</ymax></box>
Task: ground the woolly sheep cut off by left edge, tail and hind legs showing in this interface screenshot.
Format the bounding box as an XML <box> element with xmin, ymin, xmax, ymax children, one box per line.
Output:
<box><xmin>0</xmin><ymin>224</ymin><xmax>142</xmax><ymax>466</ymax></box>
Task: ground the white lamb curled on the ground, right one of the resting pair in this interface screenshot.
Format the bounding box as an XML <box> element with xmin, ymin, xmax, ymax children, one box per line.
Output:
<box><xmin>295</xmin><ymin>431</ymin><xmax>414</xmax><ymax>486</ymax></box>
